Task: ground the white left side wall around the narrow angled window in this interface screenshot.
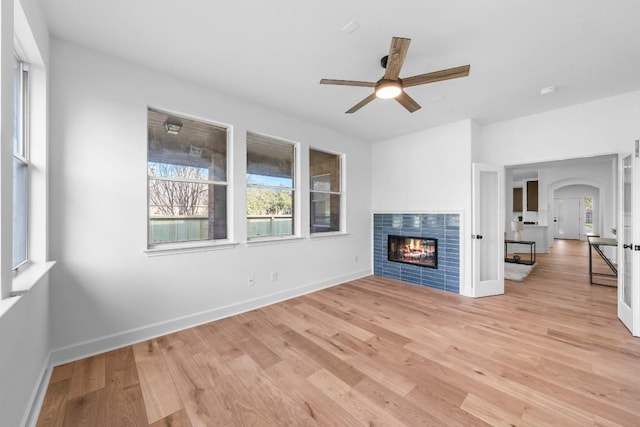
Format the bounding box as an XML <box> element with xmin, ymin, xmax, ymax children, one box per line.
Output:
<box><xmin>0</xmin><ymin>0</ymin><xmax>50</xmax><ymax>426</ymax></box>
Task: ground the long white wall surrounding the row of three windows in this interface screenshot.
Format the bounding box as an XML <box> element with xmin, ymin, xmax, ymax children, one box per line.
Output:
<box><xmin>51</xmin><ymin>40</ymin><xmax>372</xmax><ymax>362</ymax></box>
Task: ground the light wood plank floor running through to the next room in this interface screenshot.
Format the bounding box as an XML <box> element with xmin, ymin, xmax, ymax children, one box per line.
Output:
<box><xmin>38</xmin><ymin>241</ymin><xmax>640</xmax><ymax>427</ymax></box>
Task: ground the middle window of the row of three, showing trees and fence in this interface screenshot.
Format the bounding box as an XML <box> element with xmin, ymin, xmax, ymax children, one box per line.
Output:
<box><xmin>247</xmin><ymin>132</ymin><xmax>296</xmax><ymax>239</ymax></box>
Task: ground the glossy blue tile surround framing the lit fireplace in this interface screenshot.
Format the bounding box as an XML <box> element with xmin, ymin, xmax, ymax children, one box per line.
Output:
<box><xmin>373</xmin><ymin>213</ymin><xmax>460</xmax><ymax>293</ymax></box>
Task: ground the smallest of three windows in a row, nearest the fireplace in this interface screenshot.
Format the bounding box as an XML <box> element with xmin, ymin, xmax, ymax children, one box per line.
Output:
<box><xmin>309</xmin><ymin>149</ymin><xmax>343</xmax><ymax>233</ymax></box>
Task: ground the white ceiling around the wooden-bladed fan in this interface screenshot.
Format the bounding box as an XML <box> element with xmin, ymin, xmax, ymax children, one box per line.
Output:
<box><xmin>42</xmin><ymin>0</ymin><xmax>640</xmax><ymax>141</ymax></box>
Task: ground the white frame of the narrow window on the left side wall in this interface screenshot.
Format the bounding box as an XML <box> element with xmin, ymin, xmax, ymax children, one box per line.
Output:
<box><xmin>11</xmin><ymin>54</ymin><xmax>31</xmax><ymax>273</ymax></box>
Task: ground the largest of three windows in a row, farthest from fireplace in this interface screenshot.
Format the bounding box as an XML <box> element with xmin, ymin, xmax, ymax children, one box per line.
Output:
<box><xmin>147</xmin><ymin>108</ymin><xmax>228</xmax><ymax>248</ymax></box>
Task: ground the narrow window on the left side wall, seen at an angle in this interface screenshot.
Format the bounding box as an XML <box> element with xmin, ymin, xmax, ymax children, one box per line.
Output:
<box><xmin>12</xmin><ymin>57</ymin><xmax>29</xmax><ymax>269</ymax></box>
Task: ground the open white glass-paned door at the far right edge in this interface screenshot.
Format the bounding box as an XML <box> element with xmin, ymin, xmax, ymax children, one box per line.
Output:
<box><xmin>617</xmin><ymin>147</ymin><xmax>640</xmax><ymax>336</ymax></box>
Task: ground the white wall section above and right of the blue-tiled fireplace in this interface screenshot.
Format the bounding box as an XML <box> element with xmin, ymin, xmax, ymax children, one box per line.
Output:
<box><xmin>371</xmin><ymin>120</ymin><xmax>473</xmax><ymax>293</ymax></box>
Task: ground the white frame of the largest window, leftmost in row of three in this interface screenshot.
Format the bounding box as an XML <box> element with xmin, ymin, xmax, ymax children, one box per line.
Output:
<box><xmin>144</xmin><ymin>106</ymin><xmax>235</xmax><ymax>256</ymax></box>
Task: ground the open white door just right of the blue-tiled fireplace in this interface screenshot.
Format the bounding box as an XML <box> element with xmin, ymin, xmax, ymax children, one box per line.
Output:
<box><xmin>471</xmin><ymin>163</ymin><xmax>505</xmax><ymax>297</ymax></box>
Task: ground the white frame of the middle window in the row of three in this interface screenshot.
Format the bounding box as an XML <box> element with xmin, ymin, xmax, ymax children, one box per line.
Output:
<box><xmin>245</xmin><ymin>131</ymin><xmax>300</xmax><ymax>244</ymax></box>
